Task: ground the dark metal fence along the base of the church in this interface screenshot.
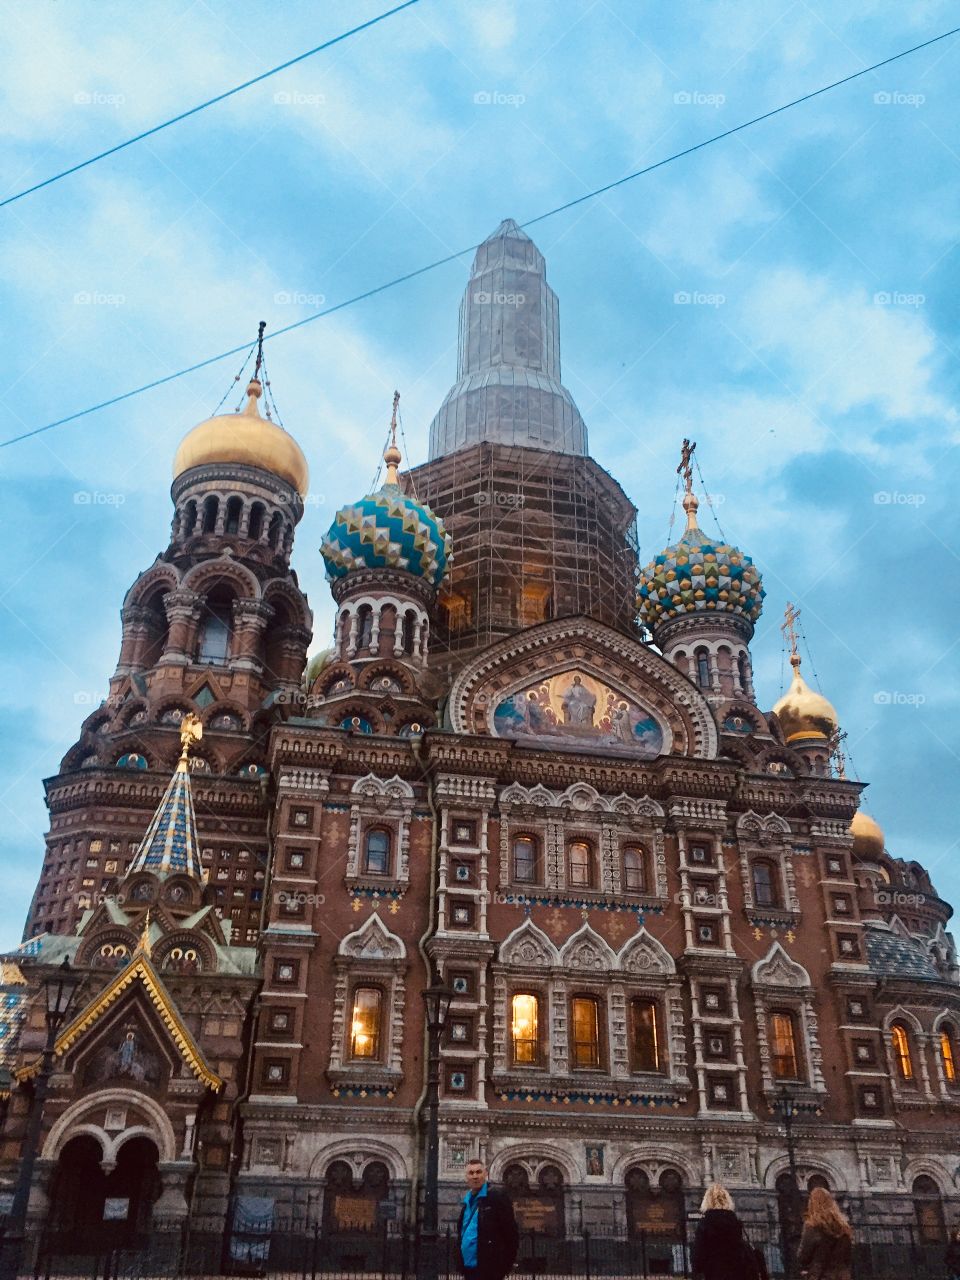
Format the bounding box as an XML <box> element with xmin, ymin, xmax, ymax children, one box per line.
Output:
<box><xmin>0</xmin><ymin>1220</ymin><xmax>947</xmax><ymax>1280</ymax></box>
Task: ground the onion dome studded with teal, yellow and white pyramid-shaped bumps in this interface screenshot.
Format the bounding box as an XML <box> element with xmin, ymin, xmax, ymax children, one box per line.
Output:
<box><xmin>636</xmin><ymin>494</ymin><xmax>767</xmax><ymax>627</ymax></box>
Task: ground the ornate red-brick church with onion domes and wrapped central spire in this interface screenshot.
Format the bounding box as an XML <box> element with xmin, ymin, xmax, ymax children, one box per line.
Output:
<box><xmin>0</xmin><ymin>221</ymin><xmax>960</xmax><ymax>1238</ymax></box>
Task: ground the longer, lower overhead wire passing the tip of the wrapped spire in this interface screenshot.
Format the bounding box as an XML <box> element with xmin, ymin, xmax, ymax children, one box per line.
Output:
<box><xmin>0</xmin><ymin>27</ymin><xmax>960</xmax><ymax>448</ymax></box>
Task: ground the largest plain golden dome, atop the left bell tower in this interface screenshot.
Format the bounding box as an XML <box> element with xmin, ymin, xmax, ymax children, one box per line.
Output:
<box><xmin>173</xmin><ymin>378</ymin><xmax>310</xmax><ymax>498</ymax></box>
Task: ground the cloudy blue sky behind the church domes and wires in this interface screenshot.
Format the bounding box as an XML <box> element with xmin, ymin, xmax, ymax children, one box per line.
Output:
<box><xmin>0</xmin><ymin>0</ymin><xmax>960</xmax><ymax>946</ymax></box>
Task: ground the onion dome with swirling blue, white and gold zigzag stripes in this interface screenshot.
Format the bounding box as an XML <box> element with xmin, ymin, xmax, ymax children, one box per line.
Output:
<box><xmin>320</xmin><ymin>407</ymin><xmax>453</xmax><ymax>586</ymax></box>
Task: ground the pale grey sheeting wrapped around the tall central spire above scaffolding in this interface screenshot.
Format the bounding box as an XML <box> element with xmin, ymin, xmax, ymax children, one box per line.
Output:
<box><xmin>430</xmin><ymin>219</ymin><xmax>586</xmax><ymax>458</ymax></box>
